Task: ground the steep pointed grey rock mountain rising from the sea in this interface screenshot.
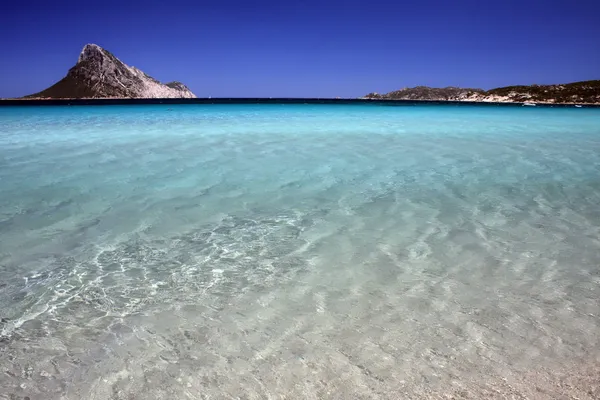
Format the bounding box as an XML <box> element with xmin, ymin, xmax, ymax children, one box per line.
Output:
<box><xmin>26</xmin><ymin>44</ymin><xmax>196</xmax><ymax>99</ymax></box>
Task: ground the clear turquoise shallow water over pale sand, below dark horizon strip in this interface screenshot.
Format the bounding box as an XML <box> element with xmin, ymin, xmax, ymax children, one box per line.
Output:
<box><xmin>0</xmin><ymin>104</ymin><xmax>600</xmax><ymax>399</ymax></box>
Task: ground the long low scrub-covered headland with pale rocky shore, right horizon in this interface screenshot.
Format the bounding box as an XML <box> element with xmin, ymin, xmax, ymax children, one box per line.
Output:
<box><xmin>364</xmin><ymin>80</ymin><xmax>600</xmax><ymax>104</ymax></box>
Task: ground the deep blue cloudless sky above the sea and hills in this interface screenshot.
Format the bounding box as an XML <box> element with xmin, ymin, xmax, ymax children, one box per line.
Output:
<box><xmin>0</xmin><ymin>0</ymin><xmax>600</xmax><ymax>97</ymax></box>
